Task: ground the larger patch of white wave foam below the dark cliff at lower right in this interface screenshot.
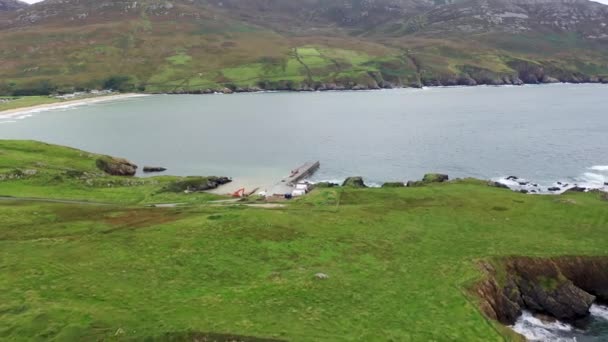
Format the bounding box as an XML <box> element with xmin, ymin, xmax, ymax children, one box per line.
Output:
<box><xmin>511</xmin><ymin>311</ymin><xmax>576</xmax><ymax>342</ymax></box>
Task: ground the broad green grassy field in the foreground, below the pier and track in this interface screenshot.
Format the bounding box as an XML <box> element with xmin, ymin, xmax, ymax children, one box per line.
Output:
<box><xmin>0</xmin><ymin>142</ymin><xmax>608</xmax><ymax>341</ymax></box>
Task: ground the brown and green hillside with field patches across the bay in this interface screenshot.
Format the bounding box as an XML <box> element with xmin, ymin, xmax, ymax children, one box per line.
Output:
<box><xmin>0</xmin><ymin>0</ymin><xmax>608</xmax><ymax>95</ymax></box>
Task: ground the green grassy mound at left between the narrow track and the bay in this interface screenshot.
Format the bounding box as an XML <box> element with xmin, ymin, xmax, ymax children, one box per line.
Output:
<box><xmin>0</xmin><ymin>140</ymin><xmax>219</xmax><ymax>204</ymax></box>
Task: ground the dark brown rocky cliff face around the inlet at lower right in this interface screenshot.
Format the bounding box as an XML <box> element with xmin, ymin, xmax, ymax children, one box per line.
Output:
<box><xmin>475</xmin><ymin>257</ymin><xmax>608</xmax><ymax>325</ymax></box>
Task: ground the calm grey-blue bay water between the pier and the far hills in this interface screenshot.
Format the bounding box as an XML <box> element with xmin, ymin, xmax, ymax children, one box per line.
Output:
<box><xmin>0</xmin><ymin>85</ymin><xmax>608</xmax><ymax>188</ymax></box>
